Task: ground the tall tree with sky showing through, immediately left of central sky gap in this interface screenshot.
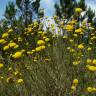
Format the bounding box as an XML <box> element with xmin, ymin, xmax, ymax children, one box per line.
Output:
<box><xmin>16</xmin><ymin>0</ymin><xmax>40</xmax><ymax>27</ymax></box>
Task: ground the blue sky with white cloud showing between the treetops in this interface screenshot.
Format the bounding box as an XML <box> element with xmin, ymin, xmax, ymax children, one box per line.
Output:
<box><xmin>0</xmin><ymin>0</ymin><xmax>96</xmax><ymax>19</ymax></box>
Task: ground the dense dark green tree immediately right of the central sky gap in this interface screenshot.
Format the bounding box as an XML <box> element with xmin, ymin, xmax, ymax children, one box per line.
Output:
<box><xmin>55</xmin><ymin>0</ymin><xmax>77</xmax><ymax>18</ymax></box>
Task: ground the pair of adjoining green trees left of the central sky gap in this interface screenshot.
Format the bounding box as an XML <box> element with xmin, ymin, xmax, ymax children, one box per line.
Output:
<box><xmin>4</xmin><ymin>0</ymin><xmax>40</xmax><ymax>27</ymax></box>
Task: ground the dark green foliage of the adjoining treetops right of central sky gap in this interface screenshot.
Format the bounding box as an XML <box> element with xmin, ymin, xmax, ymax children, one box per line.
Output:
<box><xmin>55</xmin><ymin>0</ymin><xmax>87</xmax><ymax>18</ymax></box>
